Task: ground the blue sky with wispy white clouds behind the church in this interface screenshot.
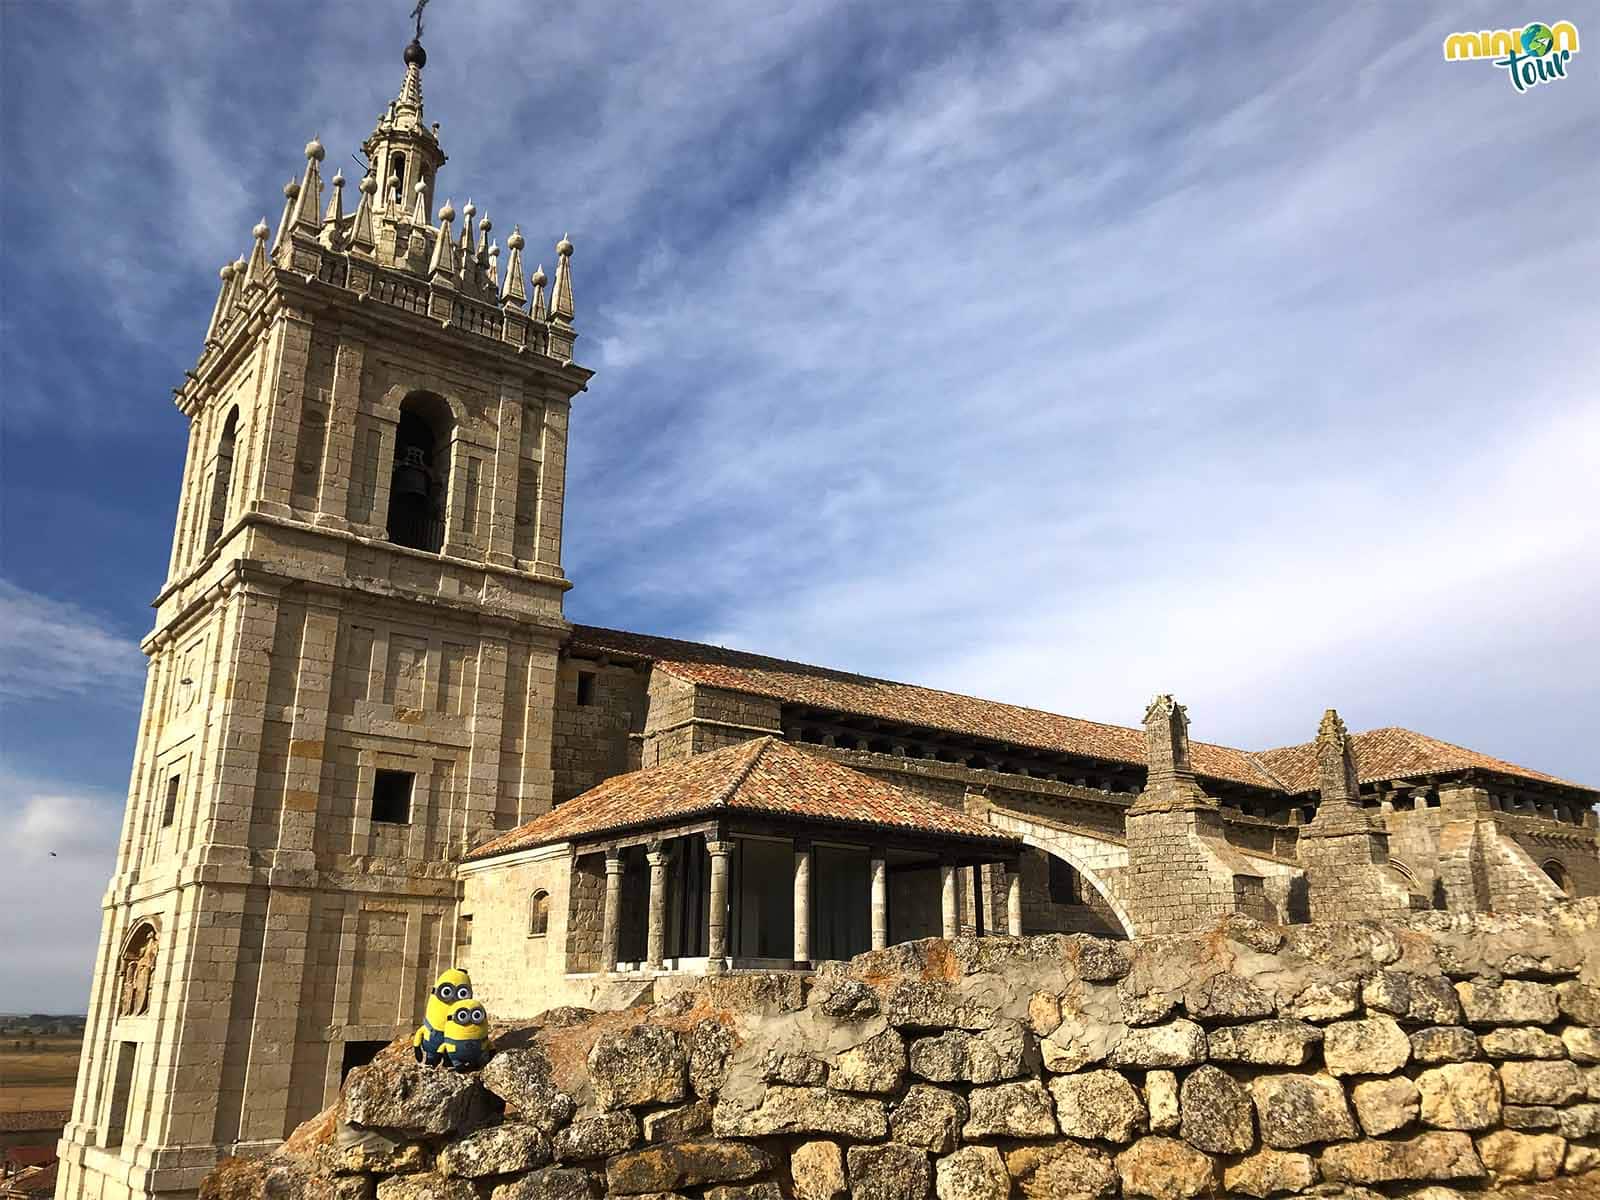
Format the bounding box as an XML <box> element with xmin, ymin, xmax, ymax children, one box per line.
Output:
<box><xmin>0</xmin><ymin>0</ymin><xmax>1600</xmax><ymax>1010</ymax></box>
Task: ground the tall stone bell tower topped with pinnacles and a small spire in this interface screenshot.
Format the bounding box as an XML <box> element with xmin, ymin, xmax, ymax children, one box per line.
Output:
<box><xmin>58</xmin><ymin>32</ymin><xmax>590</xmax><ymax>1200</ymax></box>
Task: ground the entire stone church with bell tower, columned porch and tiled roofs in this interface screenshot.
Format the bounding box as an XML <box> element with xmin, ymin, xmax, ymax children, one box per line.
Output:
<box><xmin>58</xmin><ymin>30</ymin><xmax>1600</xmax><ymax>1200</ymax></box>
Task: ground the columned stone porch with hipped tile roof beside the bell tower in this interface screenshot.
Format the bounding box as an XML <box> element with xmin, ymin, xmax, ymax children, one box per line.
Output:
<box><xmin>462</xmin><ymin>738</ymin><xmax>1022</xmax><ymax>986</ymax></box>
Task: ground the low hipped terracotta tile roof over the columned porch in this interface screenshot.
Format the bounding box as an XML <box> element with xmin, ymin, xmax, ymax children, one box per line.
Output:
<box><xmin>467</xmin><ymin>738</ymin><xmax>1014</xmax><ymax>861</ymax></box>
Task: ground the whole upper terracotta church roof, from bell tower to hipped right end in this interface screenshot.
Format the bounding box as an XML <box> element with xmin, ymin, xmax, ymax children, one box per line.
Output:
<box><xmin>573</xmin><ymin>626</ymin><xmax>1597</xmax><ymax>794</ymax></box>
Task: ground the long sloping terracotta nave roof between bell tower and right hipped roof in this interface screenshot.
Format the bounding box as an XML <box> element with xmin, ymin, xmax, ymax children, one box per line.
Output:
<box><xmin>573</xmin><ymin>626</ymin><xmax>1282</xmax><ymax>792</ymax></box>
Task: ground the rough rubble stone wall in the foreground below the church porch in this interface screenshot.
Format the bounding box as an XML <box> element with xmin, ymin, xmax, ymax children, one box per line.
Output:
<box><xmin>232</xmin><ymin>901</ymin><xmax>1600</xmax><ymax>1200</ymax></box>
